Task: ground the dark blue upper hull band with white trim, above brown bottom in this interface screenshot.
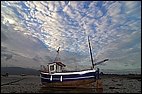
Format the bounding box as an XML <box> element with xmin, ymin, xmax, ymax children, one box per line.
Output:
<box><xmin>40</xmin><ymin>70</ymin><xmax>99</xmax><ymax>83</ymax></box>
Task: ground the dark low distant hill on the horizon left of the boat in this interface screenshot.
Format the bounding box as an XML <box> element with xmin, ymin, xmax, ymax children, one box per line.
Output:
<box><xmin>1</xmin><ymin>67</ymin><xmax>39</xmax><ymax>75</ymax></box>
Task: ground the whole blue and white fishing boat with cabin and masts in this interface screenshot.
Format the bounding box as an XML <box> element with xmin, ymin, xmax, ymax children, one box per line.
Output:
<box><xmin>40</xmin><ymin>37</ymin><xmax>108</xmax><ymax>87</ymax></box>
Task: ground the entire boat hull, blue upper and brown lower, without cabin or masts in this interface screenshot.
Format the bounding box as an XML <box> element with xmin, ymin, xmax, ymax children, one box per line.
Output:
<box><xmin>40</xmin><ymin>70</ymin><xmax>99</xmax><ymax>87</ymax></box>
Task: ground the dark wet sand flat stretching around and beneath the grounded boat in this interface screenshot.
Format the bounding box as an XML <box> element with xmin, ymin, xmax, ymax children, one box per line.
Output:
<box><xmin>1</xmin><ymin>75</ymin><xmax>141</xmax><ymax>93</ymax></box>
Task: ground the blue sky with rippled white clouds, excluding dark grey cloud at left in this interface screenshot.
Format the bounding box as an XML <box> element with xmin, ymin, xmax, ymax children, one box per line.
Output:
<box><xmin>1</xmin><ymin>1</ymin><xmax>141</xmax><ymax>72</ymax></box>
